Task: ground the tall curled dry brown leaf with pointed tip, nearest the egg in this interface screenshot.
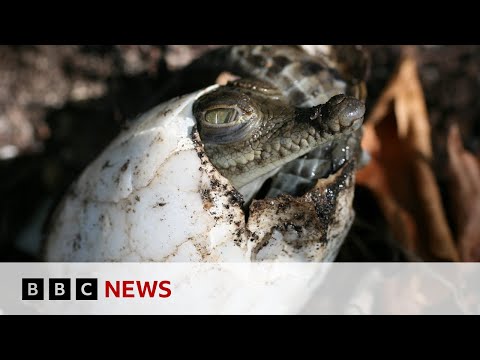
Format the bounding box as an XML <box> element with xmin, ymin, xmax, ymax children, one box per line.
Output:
<box><xmin>357</xmin><ymin>50</ymin><xmax>459</xmax><ymax>261</ymax></box>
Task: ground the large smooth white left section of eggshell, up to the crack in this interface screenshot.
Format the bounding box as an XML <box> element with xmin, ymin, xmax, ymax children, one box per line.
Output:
<box><xmin>45</xmin><ymin>86</ymin><xmax>248</xmax><ymax>261</ymax></box>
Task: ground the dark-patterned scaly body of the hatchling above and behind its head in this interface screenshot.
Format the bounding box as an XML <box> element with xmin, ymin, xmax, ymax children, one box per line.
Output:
<box><xmin>186</xmin><ymin>45</ymin><xmax>368</xmax><ymax>107</ymax></box>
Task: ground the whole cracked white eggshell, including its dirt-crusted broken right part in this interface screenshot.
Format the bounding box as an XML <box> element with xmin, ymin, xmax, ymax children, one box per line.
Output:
<box><xmin>44</xmin><ymin>86</ymin><xmax>354</xmax><ymax>262</ymax></box>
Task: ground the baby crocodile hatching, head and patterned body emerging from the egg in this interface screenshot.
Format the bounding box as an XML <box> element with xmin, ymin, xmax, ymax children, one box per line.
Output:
<box><xmin>193</xmin><ymin>45</ymin><xmax>367</xmax><ymax>201</ymax></box>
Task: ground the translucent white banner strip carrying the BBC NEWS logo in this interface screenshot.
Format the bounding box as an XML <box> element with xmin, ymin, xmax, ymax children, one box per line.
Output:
<box><xmin>0</xmin><ymin>263</ymin><xmax>480</xmax><ymax>314</ymax></box>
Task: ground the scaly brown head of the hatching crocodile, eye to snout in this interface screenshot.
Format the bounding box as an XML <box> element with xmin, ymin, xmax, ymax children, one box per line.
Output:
<box><xmin>193</xmin><ymin>80</ymin><xmax>365</xmax><ymax>188</ymax></box>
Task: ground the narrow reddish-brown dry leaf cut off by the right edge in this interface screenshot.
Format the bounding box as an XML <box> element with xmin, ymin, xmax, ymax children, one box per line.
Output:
<box><xmin>447</xmin><ymin>125</ymin><xmax>480</xmax><ymax>261</ymax></box>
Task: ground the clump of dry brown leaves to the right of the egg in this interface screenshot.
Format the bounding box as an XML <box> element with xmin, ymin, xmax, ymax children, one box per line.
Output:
<box><xmin>357</xmin><ymin>47</ymin><xmax>480</xmax><ymax>261</ymax></box>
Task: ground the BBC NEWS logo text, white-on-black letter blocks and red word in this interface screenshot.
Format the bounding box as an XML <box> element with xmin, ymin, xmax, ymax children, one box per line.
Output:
<box><xmin>22</xmin><ymin>278</ymin><xmax>172</xmax><ymax>300</ymax></box>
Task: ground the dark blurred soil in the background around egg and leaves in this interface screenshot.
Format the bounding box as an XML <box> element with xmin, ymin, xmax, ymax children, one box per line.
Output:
<box><xmin>0</xmin><ymin>45</ymin><xmax>480</xmax><ymax>261</ymax></box>
